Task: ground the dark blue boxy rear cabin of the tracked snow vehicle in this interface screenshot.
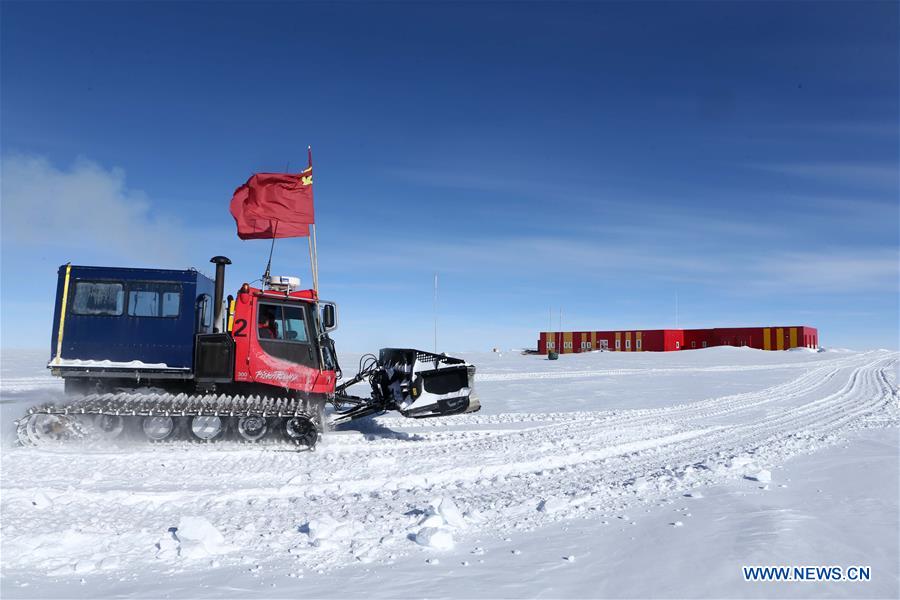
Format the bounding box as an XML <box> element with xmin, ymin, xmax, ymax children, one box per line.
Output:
<box><xmin>50</xmin><ymin>265</ymin><xmax>215</xmax><ymax>369</ymax></box>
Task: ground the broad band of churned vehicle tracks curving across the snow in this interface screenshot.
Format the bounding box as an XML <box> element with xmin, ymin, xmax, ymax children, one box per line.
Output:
<box><xmin>2</xmin><ymin>353</ymin><xmax>897</xmax><ymax>568</ymax></box>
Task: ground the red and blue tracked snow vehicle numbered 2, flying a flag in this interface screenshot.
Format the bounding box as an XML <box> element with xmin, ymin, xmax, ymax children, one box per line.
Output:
<box><xmin>17</xmin><ymin>152</ymin><xmax>480</xmax><ymax>449</ymax></box>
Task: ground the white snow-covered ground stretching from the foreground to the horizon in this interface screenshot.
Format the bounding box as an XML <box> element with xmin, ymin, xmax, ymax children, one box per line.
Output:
<box><xmin>0</xmin><ymin>348</ymin><xmax>900</xmax><ymax>598</ymax></box>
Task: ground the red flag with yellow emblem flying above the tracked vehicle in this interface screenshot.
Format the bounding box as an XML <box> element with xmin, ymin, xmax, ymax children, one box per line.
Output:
<box><xmin>231</xmin><ymin>166</ymin><xmax>316</xmax><ymax>240</ymax></box>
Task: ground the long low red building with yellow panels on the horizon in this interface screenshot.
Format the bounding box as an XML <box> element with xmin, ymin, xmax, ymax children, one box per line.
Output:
<box><xmin>538</xmin><ymin>325</ymin><xmax>819</xmax><ymax>354</ymax></box>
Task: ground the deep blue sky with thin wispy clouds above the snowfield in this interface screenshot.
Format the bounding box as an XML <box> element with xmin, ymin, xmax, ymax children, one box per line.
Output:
<box><xmin>0</xmin><ymin>2</ymin><xmax>900</xmax><ymax>351</ymax></box>
